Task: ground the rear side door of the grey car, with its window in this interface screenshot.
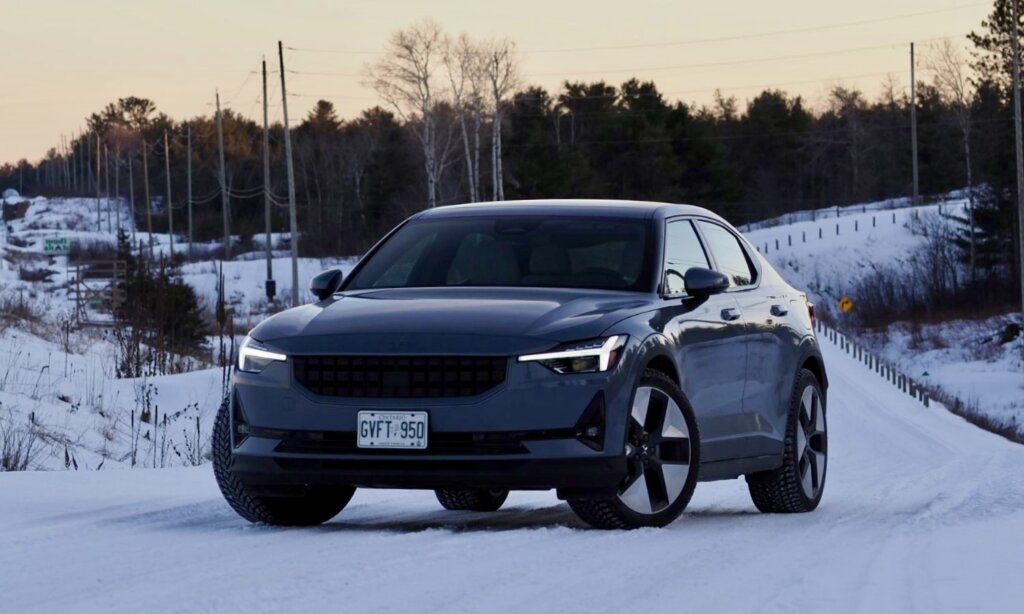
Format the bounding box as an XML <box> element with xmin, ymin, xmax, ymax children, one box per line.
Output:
<box><xmin>697</xmin><ymin>220</ymin><xmax>778</xmax><ymax>456</ymax></box>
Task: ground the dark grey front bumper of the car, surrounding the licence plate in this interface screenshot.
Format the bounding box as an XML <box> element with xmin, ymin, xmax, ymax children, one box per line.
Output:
<box><xmin>232</xmin><ymin>347</ymin><xmax>634</xmax><ymax>491</ymax></box>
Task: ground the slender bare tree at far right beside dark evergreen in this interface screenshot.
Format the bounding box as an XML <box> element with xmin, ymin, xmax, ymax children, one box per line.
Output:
<box><xmin>928</xmin><ymin>39</ymin><xmax>975</xmax><ymax>279</ymax></box>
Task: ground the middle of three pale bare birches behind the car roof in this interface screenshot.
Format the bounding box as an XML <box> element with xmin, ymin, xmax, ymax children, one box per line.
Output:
<box><xmin>444</xmin><ymin>34</ymin><xmax>485</xmax><ymax>203</ymax></box>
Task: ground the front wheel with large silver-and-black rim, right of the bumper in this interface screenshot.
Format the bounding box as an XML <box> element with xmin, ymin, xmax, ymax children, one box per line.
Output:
<box><xmin>568</xmin><ymin>369</ymin><xmax>700</xmax><ymax>529</ymax></box>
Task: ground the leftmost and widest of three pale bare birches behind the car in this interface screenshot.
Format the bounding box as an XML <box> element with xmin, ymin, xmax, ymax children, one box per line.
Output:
<box><xmin>367</xmin><ymin>19</ymin><xmax>451</xmax><ymax>208</ymax></box>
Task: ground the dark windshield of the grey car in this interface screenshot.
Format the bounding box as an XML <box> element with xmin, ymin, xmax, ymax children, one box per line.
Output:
<box><xmin>346</xmin><ymin>216</ymin><xmax>650</xmax><ymax>291</ymax></box>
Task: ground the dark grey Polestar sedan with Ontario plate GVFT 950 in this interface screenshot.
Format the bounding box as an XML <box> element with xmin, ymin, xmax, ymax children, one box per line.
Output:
<box><xmin>214</xmin><ymin>201</ymin><xmax>827</xmax><ymax>528</ymax></box>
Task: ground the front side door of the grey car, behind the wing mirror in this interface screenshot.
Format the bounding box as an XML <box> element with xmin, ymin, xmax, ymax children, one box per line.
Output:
<box><xmin>662</xmin><ymin>218</ymin><xmax>746</xmax><ymax>463</ymax></box>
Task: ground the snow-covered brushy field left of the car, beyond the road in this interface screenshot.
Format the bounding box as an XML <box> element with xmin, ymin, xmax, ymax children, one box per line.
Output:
<box><xmin>0</xmin><ymin>196</ymin><xmax>354</xmax><ymax>468</ymax></box>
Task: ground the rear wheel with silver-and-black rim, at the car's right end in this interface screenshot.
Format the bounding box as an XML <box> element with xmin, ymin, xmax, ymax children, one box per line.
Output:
<box><xmin>746</xmin><ymin>368</ymin><xmax>828</xmax><ymax>514</ymax></box>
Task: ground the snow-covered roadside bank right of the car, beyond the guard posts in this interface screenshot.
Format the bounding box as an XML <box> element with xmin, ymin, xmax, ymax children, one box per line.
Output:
<box><xmin>746</xmin><ymin>200</ymin><xmax>1024</xmax><ymax>437</ymax></box>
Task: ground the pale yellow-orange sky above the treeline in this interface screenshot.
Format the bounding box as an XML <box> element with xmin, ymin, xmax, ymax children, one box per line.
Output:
<box><xmin>0</xmin><ymin>0</ymin><xmax>991</xmax><ymax>164</ymax></box>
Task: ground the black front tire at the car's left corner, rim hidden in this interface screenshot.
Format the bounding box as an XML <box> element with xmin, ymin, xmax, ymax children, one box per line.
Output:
<box><xmin>213</xmin><ymin>401</ymin><xmax>355</xmax><ymax>527</ymax></box>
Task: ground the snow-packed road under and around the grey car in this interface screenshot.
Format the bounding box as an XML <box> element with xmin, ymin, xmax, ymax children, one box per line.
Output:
<box><xmin>0</xmin><ymin>346</ymin><xmax>1024</xmax><ymax>613</ymax></box>
